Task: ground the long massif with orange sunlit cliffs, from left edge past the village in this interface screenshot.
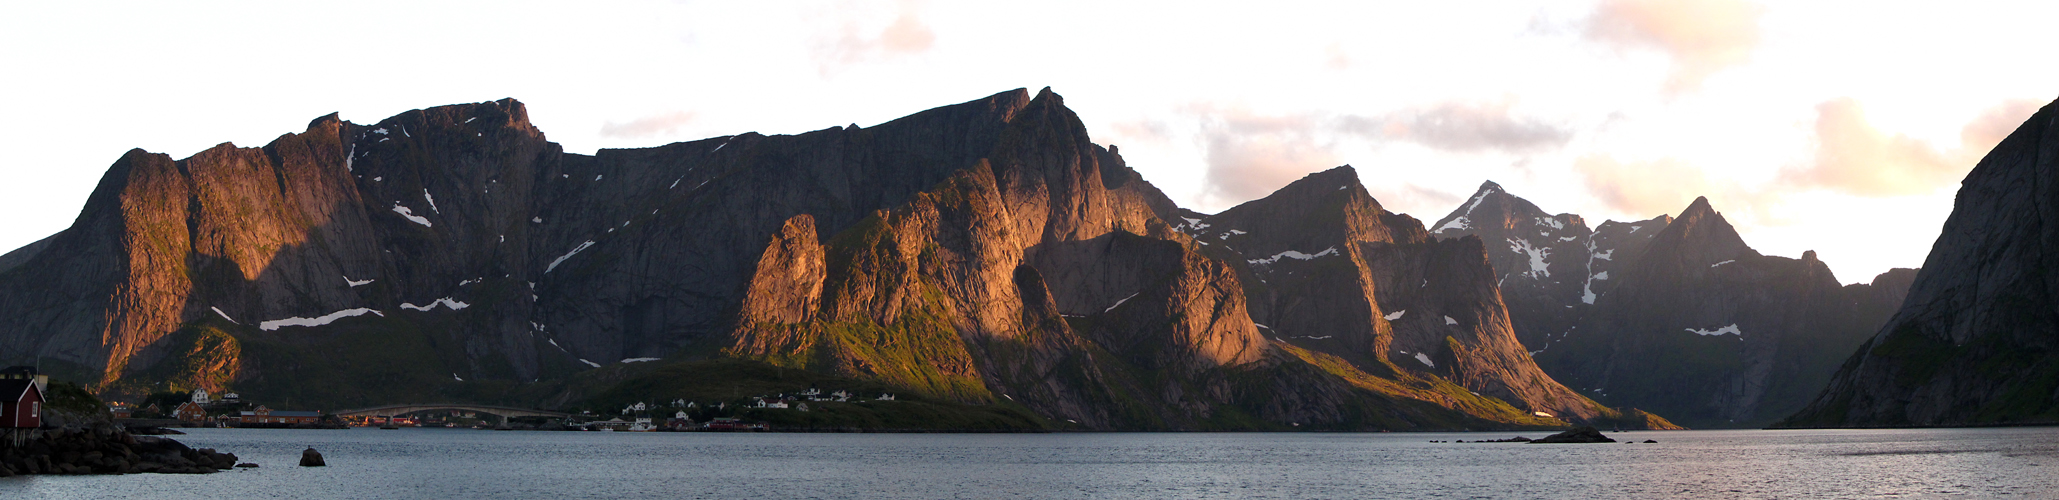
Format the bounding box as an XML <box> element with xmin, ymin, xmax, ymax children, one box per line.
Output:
<box><xmin>0</xmin><ymin>88</ymin><xmax>1670</xmax><ymax>430</ymax></box>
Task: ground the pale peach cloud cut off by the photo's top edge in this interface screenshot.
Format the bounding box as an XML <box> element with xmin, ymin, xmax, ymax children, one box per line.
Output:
<box><xmin>1585</xmin><ymin>0</ymin><xmax>1765</xmax><ymax>95</ymax></box>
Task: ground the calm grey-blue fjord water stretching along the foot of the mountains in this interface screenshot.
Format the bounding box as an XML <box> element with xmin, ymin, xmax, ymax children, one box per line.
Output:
<box><xmin>0</xmin><ymin>428</ymin><xmax>2059</xmax><ymax>498</ymax></box>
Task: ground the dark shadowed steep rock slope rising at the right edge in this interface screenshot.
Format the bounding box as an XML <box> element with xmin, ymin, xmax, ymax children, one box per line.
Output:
<box><xmin>1781</xmin><ymin>99</ymin><xmax>2059</xmax><ymax>426</ymax></box>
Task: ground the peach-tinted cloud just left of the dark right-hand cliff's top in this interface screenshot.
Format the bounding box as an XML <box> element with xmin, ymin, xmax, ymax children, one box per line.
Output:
<box><xmin>1781</xmin><ymin>97</ymin><xmax>2038</xmax><ymax>198</ymax></box>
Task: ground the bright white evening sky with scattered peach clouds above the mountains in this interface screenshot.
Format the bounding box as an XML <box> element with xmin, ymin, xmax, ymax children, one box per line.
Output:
<box><xmin>0</xmin><ymin>0</ymin><xmax>2059</xmax><ymax>282</ymax></box>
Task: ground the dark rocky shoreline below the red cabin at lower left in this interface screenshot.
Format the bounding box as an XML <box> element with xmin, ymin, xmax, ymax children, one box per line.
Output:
<box><xmin>0</xmin><ymin>422</ymin><xmax>237</xmax><ymax>477</ymax></box>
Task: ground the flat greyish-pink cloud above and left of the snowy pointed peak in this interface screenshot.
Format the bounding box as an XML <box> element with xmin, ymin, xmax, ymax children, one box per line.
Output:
<box><xmin>1338</xmin><ymin>99</ymin><xmax>1573</xmax><ymax>152</ymax></box>
